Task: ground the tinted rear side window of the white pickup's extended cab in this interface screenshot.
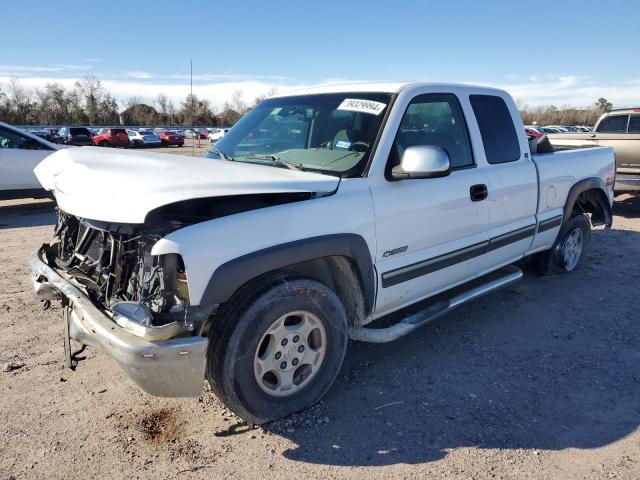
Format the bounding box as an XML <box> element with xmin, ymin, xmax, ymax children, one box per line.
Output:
<box><xmin>469</xmin><ymin>95</ymin><xmax>520</xmax><ymax>164</ymax></box>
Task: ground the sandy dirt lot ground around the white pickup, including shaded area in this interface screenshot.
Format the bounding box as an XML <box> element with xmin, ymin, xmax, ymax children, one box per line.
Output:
<box><xmin>0</xmin><ymin>149</ymin><xmax>640</xmax><ymax>479</ymax></box>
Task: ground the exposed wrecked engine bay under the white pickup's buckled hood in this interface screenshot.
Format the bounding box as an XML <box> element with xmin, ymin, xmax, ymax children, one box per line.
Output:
<box><xmin>49</xmin><ymin>211</ymin><xmax>189</xmax><ymax>325</ymax></box>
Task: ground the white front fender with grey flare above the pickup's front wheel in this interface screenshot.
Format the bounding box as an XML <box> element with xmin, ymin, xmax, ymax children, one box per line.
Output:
<box><xmin>151</xmin><ymin>179</ymin><xmax>376</xmax><ymax>305</ymax></box>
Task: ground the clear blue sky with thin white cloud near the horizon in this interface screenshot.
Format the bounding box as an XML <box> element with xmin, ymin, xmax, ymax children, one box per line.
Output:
<box><xmin>0</xmin><ymin>0</ymin><xmax>640</xmax><ymax>107</ymax></box>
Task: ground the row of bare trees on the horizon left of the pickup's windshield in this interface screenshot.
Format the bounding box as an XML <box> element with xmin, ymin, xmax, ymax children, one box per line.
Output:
<box><xmin>0</xmin><ymin>76</ymin><xmax>276</xmax><ymax>127</ymax></box>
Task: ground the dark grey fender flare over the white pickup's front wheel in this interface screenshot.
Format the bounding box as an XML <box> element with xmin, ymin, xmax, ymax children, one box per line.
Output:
<box><xmin>200</xmin><ymin>233</ymin><xmax>376</xmax><ymax>312</ymax></box>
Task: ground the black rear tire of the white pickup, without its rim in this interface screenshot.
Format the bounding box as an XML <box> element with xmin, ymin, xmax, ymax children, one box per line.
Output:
<box><xmin>529</xmin><ymin>213</ymin><xmax>591</xmax><ymax>275</ymax></box>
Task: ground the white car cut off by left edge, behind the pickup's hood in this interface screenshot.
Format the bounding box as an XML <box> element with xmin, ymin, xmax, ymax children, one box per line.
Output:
<box><xmin>0</xmin><ymin>122</ymin><xmax>65</xmax><ymax>199</ymax></box>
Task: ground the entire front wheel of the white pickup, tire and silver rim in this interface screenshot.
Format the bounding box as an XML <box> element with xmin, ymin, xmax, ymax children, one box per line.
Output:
<box><xmin>207</xmin><ymin>278</ymin><xmax>348</xmax><ymax>424</ymax></box>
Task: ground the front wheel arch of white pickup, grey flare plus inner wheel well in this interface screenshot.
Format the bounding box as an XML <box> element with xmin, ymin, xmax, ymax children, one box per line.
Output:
<box><xmin>201</xmin><ymin>233</ymin><xmax>376</xmax><ymax>325</ymax></box>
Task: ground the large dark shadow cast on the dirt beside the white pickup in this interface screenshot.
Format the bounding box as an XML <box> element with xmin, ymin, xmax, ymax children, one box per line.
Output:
<box><xmin>255</xmin><ymin>230</ymin><xmax>640</xmax><ymax>466</ymax></box>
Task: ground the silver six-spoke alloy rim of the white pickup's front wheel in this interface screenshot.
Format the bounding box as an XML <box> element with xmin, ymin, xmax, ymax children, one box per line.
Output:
<box><xmin>253</xmin><ymin>310</ymin><xmax>327</xmax><ymax>397</ymax></box>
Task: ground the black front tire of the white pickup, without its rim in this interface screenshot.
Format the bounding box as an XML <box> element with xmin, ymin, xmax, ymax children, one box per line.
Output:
<box><xmin>207</xmin><ymin>277</ymin><xmax>348</xmax><ymax>425</ymax></box>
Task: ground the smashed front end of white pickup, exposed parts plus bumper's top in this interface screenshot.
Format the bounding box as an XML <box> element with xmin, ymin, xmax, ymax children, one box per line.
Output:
<box><xmin>40</xmin><ymin>211</ymin><xmax>213</xmax><ymax>341</ymax></box>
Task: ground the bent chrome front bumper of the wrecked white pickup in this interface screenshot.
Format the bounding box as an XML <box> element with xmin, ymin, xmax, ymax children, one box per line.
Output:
<box><xmin>29</xmin><ymin>245</ymin><xmax>208</xmax><ymax>397</ymax></box>
